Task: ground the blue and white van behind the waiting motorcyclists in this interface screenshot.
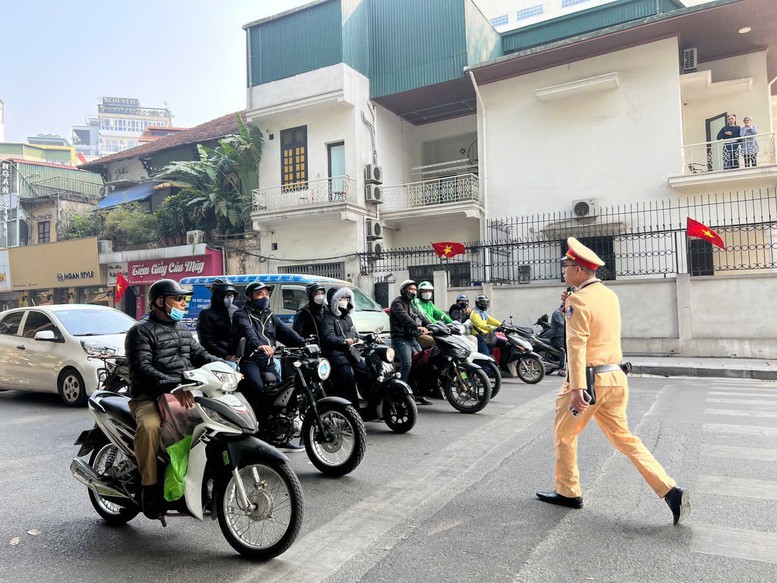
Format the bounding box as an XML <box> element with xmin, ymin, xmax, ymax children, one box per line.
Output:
<box><xmin>180</xmin><ymin>273</ymin><xmax>389</xmax><ymax>333</ymax></box>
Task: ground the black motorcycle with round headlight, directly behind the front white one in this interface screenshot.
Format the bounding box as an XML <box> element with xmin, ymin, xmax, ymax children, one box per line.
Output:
<box><xmin>252</xmin><ymin>344</ymin><xmax>367</xmax><ymax>477</ymax></box>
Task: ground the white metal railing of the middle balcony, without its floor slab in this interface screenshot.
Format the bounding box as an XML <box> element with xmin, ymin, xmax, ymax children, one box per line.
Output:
<box><xmin>382</xmin><ymin>174</ymin><xmax>480</xmax><ymax>211</ymax></box>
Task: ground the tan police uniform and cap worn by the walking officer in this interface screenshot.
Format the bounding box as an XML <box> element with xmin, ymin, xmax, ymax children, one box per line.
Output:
<box><xmin>554</xmin><ymin>237</ymin><xmax>675</xmax><ymax>498</ymax></box>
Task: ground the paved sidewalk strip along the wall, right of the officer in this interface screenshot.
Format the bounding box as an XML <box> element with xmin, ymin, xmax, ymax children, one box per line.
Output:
<box><xmin>623</xmin><ymin>356</ymin><xmax>777</xmax><ymax>381</ymax></box>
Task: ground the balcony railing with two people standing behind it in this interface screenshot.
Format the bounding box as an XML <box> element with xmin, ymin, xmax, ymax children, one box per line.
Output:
<box><xmin>682</xmin><ymin>134</ymin><xmax>777</xmax><ymax>175</ymax></box>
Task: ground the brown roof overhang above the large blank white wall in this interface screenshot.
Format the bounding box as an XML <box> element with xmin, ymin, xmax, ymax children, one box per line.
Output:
<box><xmin>468</xmin><ymin>0</ymin><xmax>777</xmax><ymax>93</ymax></box>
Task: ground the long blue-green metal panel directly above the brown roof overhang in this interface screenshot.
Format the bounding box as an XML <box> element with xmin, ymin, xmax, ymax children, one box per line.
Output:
<box><xmin>502</xmin><ymin>0</ymin><xmax>683</xmax><ymax>54</ymax></box>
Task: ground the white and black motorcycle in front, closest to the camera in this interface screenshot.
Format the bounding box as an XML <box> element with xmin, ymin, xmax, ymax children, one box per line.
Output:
<box><xmin>70</xmin><ymin>363</ymin><xmax>304</xmax><ymax>561</ymax></box>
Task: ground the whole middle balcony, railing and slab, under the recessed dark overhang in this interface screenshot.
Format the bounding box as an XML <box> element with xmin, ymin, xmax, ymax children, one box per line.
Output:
<box><xmin>381</xmin><ymin>174</ymin><xmax>483</xmax><ymax>221</ymax></box>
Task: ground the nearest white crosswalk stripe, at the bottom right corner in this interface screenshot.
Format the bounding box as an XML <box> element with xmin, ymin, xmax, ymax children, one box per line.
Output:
<box><xmin>690</xmin><ymin>525</ymin><xmax>777</xmax><ymax>564</ymax></box>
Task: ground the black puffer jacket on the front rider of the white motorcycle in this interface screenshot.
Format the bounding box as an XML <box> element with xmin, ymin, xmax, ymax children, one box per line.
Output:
<box><xmin>124</xmin><ymin>312</ymin><xmax>219</xmax><ymax>399</ymax></box>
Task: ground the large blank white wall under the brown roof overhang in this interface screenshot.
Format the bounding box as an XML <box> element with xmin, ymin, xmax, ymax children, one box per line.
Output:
<box><xmin>480</xmin><ymin>38</ymin><xmax>682</xmax><ymax>217</ymax></box>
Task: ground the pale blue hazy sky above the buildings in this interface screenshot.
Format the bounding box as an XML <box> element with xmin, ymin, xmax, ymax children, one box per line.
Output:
<box><xmin>0</xmin><ymin>0</ymin><xmax>309</xmax><ymax>142</ymax></box>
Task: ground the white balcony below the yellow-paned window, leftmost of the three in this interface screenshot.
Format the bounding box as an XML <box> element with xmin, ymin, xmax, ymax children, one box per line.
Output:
<box><xmin>251</xmin><ymin>176</ymin><xmax>366</xmax><ymax>226</ymax></box>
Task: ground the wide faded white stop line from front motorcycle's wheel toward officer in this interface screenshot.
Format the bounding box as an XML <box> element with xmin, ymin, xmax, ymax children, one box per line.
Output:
<box><xmin>237</xmin><ymin>391</ymin><xmax>556</xmax><ymax>583</ymax></box>
